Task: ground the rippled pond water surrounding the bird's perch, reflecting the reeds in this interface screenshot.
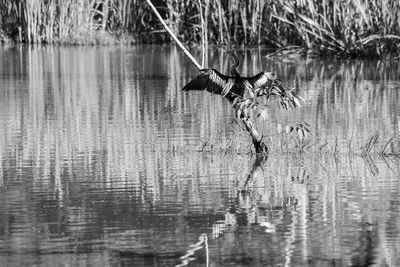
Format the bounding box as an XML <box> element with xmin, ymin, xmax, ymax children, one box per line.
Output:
<box><xmin>0</xmin><ymin>46</ymin><xmax>400</xmax><ymax>266</ymax></box>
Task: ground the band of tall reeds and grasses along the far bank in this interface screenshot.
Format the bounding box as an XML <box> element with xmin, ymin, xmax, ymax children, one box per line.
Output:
<box><xmin>0</xmin><ymin>0</ymin><xmax>400</xmax><ymax>58</ymax></box>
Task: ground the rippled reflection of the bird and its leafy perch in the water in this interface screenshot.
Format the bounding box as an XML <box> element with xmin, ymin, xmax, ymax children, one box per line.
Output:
<box><xmin>212</xmin><ymin>154</ymin><xmax>309</xmax><ymax>238</ymax></box>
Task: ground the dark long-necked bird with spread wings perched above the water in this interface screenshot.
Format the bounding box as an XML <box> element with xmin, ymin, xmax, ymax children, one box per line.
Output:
<box><xmin>182</xmin><ymin>51</ymin><xmax>300</xmax><ymax>109</ymax></box>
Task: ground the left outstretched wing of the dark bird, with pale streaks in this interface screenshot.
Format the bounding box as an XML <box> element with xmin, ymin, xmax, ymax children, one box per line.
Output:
<box><xmin>182</xmin><ymin>69</ymin><xmax>235</xmax><ymax>96</ymax></box>
